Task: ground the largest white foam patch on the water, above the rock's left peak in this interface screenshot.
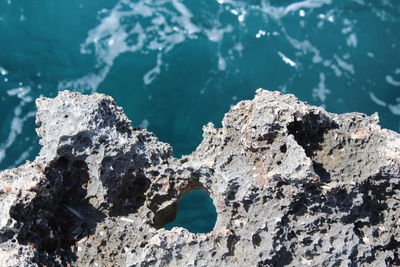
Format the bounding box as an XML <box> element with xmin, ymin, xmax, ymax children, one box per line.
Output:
<box><xmin>58</xmin><ymin>0</ymin><xmax>232</xmax><ymax>91</ymax></box>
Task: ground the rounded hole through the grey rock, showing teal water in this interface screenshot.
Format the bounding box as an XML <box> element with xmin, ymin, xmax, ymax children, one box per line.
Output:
<box><xmin>164</xmin><ymin>190</ymin><xmax>217</xmax><ymax>233</ymax></box>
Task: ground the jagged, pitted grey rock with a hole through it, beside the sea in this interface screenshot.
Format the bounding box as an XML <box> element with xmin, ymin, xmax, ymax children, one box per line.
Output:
<box><xmin>0</xmin><ymin>89</ymin><xmax>400</xmax><ymax>266</ymax></box>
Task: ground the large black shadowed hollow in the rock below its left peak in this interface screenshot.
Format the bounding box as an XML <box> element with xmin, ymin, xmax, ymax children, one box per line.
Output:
<box><xmin>10</xmin><ymin>155</ymin><xmax>104</xmax><ymax>266</ymax></box>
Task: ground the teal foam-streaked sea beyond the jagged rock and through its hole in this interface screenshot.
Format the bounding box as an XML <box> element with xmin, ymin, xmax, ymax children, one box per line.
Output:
<box><xmin>0</xmin><ymin>0</ymin><xmax>400</xmax><ymax>232</ymax></box>
